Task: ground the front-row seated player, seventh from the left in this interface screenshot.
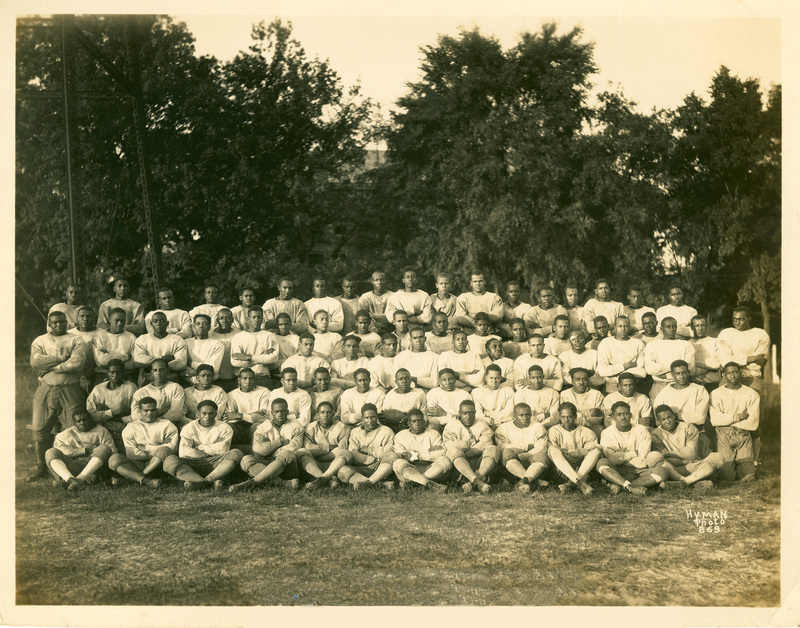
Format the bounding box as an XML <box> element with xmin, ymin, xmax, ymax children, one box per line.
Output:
<box><xmin>392</xmin><ymin>410</ymin><xmax>453</xmax><ymax>493</ymax></box>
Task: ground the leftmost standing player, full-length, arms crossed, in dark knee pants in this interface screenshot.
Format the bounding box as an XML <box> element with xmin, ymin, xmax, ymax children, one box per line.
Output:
<box><xmin>28</xmin><ymin>312</ymin><xmax>86</xmax><ymax>481</ymax></box>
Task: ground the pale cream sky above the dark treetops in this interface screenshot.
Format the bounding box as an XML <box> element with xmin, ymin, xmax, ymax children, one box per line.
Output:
<box><xmin>174</xmin><ymin>11</ymin><xmax>781</xmax><ymax>111</ymax></box>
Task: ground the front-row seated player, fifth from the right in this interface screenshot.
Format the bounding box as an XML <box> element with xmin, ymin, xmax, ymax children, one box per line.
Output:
<box><xmin>442</xmin><ymin>399</ymin><xmax>500</xmax><ymax>493</ymax></box>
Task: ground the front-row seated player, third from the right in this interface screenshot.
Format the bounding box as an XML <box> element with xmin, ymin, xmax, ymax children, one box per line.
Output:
<box><xmin>547</xmin><ymin>402</ymin><xmax>603</xmax><ymax>495</ymax></box>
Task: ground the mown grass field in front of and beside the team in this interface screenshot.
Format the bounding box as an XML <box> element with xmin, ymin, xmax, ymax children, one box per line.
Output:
<box><xmin>16</xmin><ymin>368</ymin><xmax>780</xmax><ymax>607</ymax></box>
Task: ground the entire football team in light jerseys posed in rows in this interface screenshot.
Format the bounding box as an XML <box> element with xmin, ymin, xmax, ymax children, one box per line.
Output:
<box><xmin>31</xmin><ymin>269</ymin><xmax>769</xmax><ymax>492</ymax></box>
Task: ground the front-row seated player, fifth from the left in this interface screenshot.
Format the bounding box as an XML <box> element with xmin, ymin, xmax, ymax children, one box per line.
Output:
<box><xmin>296</xmin><ymin>401</ymin><xmax>350</xmax><ymax>490</ymax></box>
